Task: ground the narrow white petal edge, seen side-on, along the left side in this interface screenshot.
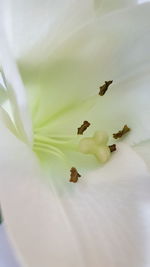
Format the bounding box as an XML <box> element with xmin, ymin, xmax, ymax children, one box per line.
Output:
<box><xmin>0</xmin><ymin>23</ymin><xmax>32</xmax><ymax>142</ymax></box>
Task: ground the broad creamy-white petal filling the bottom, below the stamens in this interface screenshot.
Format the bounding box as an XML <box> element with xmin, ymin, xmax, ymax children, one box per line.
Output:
<box><xmin>0</xmin><ymin>122</ymin><xmax>149</xmax><ymax>267</ymax></box>
